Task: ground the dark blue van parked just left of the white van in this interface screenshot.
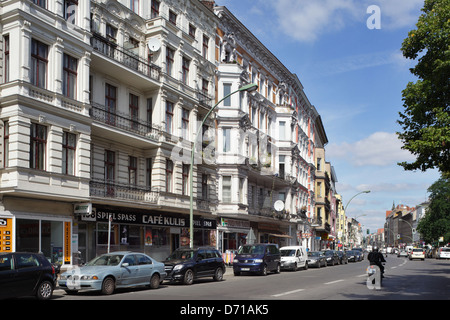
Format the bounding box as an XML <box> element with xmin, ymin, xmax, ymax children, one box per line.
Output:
<box><xmin>233</xmin><ymin>243</ymin><xmax>281</xmax><ymax>276</ymax></box>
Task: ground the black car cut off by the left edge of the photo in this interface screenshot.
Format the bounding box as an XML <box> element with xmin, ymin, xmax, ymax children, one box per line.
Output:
<box><xmin>0</xmin><ymin>252</ymin><xmax>56</xmax><ymax>300</ymax></box>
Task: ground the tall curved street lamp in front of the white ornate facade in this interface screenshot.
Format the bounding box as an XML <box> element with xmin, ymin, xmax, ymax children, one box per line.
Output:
<box><xmin>189</xmin><ymin>83</ymin><xmax>258</xmax><ymax>248</ymax></box>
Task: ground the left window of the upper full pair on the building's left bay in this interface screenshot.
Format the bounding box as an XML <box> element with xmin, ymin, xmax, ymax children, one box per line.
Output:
<box><xmin>31</xmin><ymin>39</ymin><xmax>48</xmax><ymax>89</ymax></box>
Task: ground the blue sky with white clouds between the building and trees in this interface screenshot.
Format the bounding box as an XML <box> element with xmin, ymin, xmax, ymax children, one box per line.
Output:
<box><xmin>220</xmin><ymin>0</ymin><xmax>439</xmax><ymax>232</ymax></box>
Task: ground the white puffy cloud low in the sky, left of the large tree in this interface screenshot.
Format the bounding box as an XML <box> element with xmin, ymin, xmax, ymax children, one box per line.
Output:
<box><xmin>326</xmin><ymin>132</ymin><xmax>414</xmax><ymax>167</ymax></box>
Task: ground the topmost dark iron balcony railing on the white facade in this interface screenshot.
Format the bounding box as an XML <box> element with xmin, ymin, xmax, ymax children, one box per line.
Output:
<box><xmin>91</xmin><ymin>33</ymin><xmax>161</xmax><ymax>81</ymax></box>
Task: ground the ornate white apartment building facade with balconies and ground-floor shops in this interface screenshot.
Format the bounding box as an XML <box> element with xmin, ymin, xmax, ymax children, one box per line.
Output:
<box><xmin>0</xmin><ymin>0</ymin><xmax>336</xmax><ymax>265</ymax></box>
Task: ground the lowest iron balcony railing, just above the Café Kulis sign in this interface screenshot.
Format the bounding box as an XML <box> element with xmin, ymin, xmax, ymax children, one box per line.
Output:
<box><xmin>89</xmin><ymin>180</ymin><xmax>159</xmax><ymax>204</ymax></box>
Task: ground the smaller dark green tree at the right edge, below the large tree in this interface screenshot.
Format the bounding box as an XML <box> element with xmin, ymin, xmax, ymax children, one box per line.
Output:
<box><xmin>417</xmin><ymin>177</ymin><xmax>450</xmax><ymax>243</ymax></box>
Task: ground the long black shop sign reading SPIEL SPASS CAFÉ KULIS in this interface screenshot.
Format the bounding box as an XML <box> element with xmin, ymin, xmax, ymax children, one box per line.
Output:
<box><xmin>80</xmin><ymin>208</ymin><xmax>216</xmax><ymax>229</ymax></box>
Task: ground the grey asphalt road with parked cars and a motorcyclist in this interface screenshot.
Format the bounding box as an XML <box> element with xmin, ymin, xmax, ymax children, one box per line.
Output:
<box><xmin>53</xmin><ymin>255</ymin><xmax>450</xmax><ymax>302</ymax></box>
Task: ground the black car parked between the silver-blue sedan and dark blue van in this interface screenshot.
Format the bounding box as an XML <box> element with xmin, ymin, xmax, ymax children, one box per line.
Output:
<box><xmin>163</xmin><ymin>247</ymin><xmax>225</xmax><ymax>284</ymax></box>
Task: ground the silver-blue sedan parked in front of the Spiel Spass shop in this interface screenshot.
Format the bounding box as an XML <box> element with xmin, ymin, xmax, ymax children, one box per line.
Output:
<box><xmin>58</xmin><ymin>251</ymin><xmax>166</xmax><ymax>295</ymax></box>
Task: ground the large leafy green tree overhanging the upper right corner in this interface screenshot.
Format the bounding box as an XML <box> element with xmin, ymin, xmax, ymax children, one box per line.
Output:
<box><xmin>397</xmin><ymin>0</ymin><xmax>450</xmax><ymax>176</ymax></box>
